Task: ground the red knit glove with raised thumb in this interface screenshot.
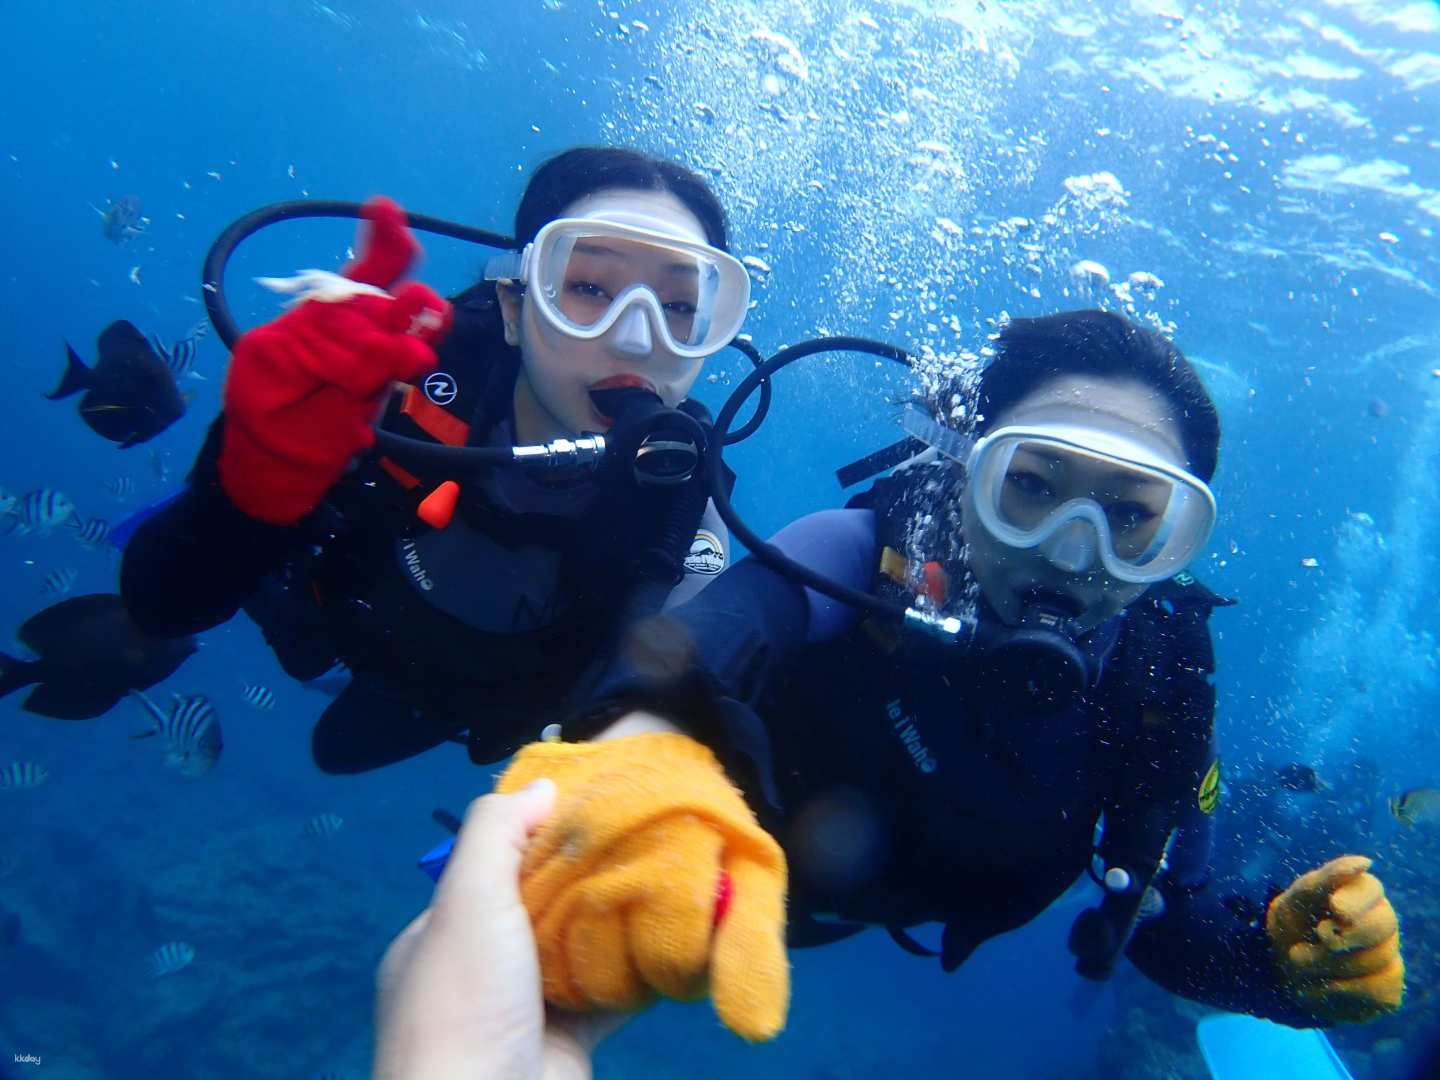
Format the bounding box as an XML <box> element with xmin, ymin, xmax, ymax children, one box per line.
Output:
<box><xmin>220</xmin><ymin>197</ymin><xmax>451</xmax><ymax>526</ymax></box>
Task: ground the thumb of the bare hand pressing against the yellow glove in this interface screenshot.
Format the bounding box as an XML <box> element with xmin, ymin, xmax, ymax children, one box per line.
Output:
<box><xmin>433</xmin><ymin>778</ymin><xmax>556</xmax><ymax>907</ymax></box>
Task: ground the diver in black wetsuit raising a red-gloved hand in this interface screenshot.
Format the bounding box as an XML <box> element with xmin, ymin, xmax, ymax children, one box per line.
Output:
<box><xmin>121</xmin><ymin>148</ymin><xmax>750</xmax><ymax>773</ymax></box>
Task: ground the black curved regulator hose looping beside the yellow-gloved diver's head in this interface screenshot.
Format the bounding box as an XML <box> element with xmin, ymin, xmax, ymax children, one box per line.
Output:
<box><xmin>706</xmin><ymin>337</ymin><xmax>912</xmax><ymax>622</ymax></box>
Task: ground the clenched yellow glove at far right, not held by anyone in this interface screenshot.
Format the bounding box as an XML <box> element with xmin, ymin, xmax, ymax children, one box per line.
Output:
<box><xmin>1264</xmin><ymin>855</ymin><xmax>1405</xmax><ymax>1022</ymax></box>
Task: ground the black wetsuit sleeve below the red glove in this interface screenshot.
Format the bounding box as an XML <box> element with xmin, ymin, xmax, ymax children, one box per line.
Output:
<box><xmin>120</xmin><ymin>416</ymin><xmax>302</xmax><ymax>636</ymax></box>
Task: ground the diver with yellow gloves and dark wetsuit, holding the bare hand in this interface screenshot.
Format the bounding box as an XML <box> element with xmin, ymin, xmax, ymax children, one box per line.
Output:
<box><xmin>564</xmin><ymin>311</ymin><xmax>1404</xmax><ymax>1025</ymax></box>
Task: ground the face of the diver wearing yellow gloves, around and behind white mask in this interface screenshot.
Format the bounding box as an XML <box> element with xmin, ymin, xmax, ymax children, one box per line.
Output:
<box><xmin>962</xmin><ymin>376</ymin><xmax>1187</xmax><ymax>631</ymax></box>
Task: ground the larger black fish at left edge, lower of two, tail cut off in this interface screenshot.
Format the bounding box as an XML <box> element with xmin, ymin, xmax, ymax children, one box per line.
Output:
<box><xmin>0</xmin><ymin>593</ymin><xmax>196</xmax><ymax>720</ymax></box>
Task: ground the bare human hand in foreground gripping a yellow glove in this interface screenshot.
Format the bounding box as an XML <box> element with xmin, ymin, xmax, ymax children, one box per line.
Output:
<box><xmin>374</xmin><ymin>780</ymin><xmax>624</xmax><ymax>1080</ymax></box>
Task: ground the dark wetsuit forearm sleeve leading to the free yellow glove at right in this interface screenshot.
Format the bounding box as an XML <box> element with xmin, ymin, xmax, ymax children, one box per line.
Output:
<box><xmin>1126</xmin><ymin>811</ymin><xmax>1322</xmax><ymax>1027</ymax></box>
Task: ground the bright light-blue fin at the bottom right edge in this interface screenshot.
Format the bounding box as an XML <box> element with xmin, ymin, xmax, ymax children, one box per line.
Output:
<box><xmin>1195</xmin><ymin>1012</ymin><xmax>1352</xmax><ymax>1080</ymax></box>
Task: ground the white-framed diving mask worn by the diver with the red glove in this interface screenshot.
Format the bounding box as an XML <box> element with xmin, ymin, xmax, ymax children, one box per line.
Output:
<box><xmin>485</xmin><ymin>210</ymin><xmax>750</xmax><ymax>360</ymax></box>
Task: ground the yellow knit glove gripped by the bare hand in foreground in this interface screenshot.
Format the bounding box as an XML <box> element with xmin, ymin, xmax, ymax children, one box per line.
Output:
<box><xmin>495</xmin><ymin>733</ymin><xmax>791</xmax><ymax>1041</ymax></box>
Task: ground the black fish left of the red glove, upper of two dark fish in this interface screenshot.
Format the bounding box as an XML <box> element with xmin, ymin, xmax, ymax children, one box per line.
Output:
<box><xmin>45</xmin><ymin>320</ymin><xmax>184</xmax><ymax>449</ymax></box>
